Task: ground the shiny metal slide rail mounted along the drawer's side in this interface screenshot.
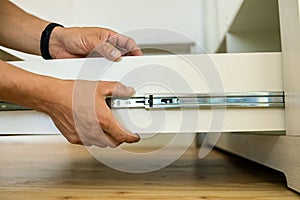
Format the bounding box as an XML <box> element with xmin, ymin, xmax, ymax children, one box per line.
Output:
<box><xmin>0</xmin><ymin>92</ymin><xmax>284</xmax><ymax>111</ymax></box>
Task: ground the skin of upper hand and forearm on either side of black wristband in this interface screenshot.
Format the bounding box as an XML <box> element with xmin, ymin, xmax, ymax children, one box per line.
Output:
<box><xmin>0</xmin><ymin>0</ymin><xmax>142</xmax><ymax>60</ymax></box>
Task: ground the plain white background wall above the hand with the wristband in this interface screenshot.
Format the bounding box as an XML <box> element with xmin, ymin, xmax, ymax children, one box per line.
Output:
<box><xmin>5</xmin><ymin>0</ymin><xmax>202</xmax><ymax>59</ymax></box>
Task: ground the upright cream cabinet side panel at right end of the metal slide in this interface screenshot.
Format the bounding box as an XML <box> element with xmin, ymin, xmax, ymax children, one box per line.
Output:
<box><xmin>279</xmin><ymin>0</ymin><xmax>300</xmax><ymax>136</ymax></box>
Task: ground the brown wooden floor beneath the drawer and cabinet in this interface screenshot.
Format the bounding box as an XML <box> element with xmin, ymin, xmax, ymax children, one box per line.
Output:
<box><xmin>0</xmin><ymin>136</ymin><xmax>300</xmax><ymax>200</ymax></box>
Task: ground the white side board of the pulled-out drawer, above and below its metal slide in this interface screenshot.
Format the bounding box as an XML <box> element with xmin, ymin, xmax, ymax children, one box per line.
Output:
<box><xmin>0</xmin><ymin>53</ymin><xmax>285</xmax><ymax>134</ymax></box>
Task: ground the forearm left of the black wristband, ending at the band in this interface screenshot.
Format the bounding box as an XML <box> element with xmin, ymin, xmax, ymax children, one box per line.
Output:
<box><xmin>0</xmin><ymin>0</ymin><xmax>49</xmax><ymax>55</ymax></box>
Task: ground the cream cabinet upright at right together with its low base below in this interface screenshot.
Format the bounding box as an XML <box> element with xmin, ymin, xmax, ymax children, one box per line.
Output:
<box><xmin>216</xmin><ymin>0</ymin><xmax>300</xmax><ymax>192</ymax></box>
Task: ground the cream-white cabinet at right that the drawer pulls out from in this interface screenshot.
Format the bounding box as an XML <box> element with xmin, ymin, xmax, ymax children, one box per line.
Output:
<box><xmin>202</xmin><ymin>0</ymin><xmax>300</xmax><ymax>192</ymax></box>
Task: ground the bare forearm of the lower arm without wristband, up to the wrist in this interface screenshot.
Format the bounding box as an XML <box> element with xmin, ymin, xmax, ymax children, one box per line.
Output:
<box><xmin>0</xmin><ymin>60</ymin><xmax>65</xmax><ymax>113</ymax></box>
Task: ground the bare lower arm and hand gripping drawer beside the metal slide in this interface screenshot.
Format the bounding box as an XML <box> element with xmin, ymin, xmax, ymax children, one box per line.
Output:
<box><xmin>0</xmin><ymin>60</ymin><xmax>140</xmax><ymax>147</ymax></box>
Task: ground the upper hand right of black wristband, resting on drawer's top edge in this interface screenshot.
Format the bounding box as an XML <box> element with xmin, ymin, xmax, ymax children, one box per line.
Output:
<box><xmin>49</xmin><ymin>27</ymin><xmax>143</xmax><ymax>61</ymax></box>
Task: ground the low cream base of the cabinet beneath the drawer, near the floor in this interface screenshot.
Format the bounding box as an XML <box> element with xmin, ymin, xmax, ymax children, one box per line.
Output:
<box><xmin>216</xmin><ymin>133</ymin><xmax>300</xmax><ymax>192</ymax></box>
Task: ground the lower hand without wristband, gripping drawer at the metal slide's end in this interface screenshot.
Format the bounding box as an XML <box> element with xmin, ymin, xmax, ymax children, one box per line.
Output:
<box><xmin>46</xmin><ymin>81</ymin><xmax>140</xmax><ymax>147</ymax></box>
